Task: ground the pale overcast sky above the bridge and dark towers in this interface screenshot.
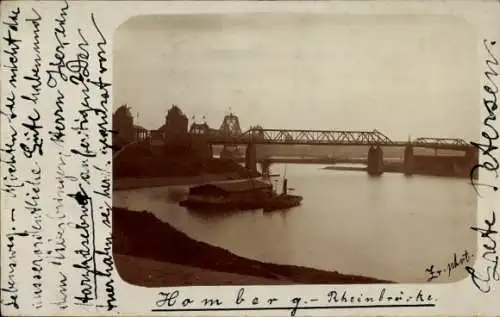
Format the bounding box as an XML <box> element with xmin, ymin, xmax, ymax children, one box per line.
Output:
<box><xmin>113</xmin><ymin>14</ymin><xmax>480</xmax><ymax>140</ymax></box>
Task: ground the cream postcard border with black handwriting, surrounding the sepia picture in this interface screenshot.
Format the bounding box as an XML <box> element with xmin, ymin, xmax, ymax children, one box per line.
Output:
<box><xmin>1</xmin><ymin>1</ymin><xmax>500</xmax><ymax>316</ymax></box>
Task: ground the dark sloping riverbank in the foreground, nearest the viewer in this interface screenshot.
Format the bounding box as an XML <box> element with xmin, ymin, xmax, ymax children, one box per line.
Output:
<box><xmin>113</xmin><ymin>207</ymin><xmax>388</xmax><ymax>286</ymax></box>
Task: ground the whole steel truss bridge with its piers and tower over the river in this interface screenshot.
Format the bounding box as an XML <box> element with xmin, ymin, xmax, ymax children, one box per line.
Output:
<box><xmin>113</xmin><ymin>114</ymin><xmax>478</xmax><ymax>175</ymax></box>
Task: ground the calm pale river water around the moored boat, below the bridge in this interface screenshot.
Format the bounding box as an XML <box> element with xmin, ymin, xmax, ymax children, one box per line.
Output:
<box><xmin>113</xmin><ymin>164</ymin><xmax>477</xmax><ymax>283</ymax></box>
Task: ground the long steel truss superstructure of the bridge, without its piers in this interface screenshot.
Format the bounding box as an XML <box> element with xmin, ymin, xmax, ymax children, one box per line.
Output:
<box><xmin>191</xmin><ymin>128</ymin><xmax>471</xmax><ymax>150</ymax></box>
